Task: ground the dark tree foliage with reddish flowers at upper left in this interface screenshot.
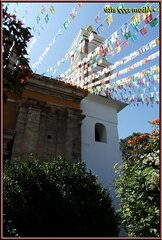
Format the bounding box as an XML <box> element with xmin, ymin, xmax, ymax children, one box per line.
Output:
<box><xmin>3</xmin><ymin>7</ymin><xmax>32</xmax><ymax>96</ymax></box>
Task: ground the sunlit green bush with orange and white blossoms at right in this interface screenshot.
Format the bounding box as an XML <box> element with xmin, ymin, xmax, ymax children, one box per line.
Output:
<box><xmin>114</xmin><ymin>120</ymin><xmax>160</xmax><ymax>237</ymax></box>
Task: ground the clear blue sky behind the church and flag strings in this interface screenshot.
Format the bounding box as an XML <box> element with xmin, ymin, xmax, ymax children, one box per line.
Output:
<box><xmin>5</xmin><ymin>2</ymin><xmax>159</xmax><ymax>138</ymax></box>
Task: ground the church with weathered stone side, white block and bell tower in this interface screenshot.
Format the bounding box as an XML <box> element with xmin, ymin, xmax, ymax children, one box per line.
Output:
<box><xmin>3</xmin><ymin>30</ymin><xmax>126</xmax><ymax>202</ymax></box>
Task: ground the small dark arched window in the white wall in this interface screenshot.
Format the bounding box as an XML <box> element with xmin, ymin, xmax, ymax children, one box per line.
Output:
<box><xmin>95</xmin><ymin>123</ymin><xmax>107</xmax><ymax>143</ymax></box>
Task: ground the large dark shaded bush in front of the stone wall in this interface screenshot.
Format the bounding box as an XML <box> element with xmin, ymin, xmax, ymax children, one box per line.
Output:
<box><xmin>4</xmin><ymin>157</ymin><xmax>118</xmax><ymax>237</ymax></box>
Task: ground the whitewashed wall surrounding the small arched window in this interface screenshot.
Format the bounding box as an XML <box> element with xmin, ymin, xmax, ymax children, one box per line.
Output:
<box><xmin>81</xmin><ymin>94</ymin><xmax>125</xmax><ymax>206</ymax></box>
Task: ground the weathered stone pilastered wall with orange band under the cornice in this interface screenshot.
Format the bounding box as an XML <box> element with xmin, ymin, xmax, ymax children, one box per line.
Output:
<box><xmin>4</xmin><ymin>75</ymin><xmax>85</xmax><ymax>160</ymax></box>
